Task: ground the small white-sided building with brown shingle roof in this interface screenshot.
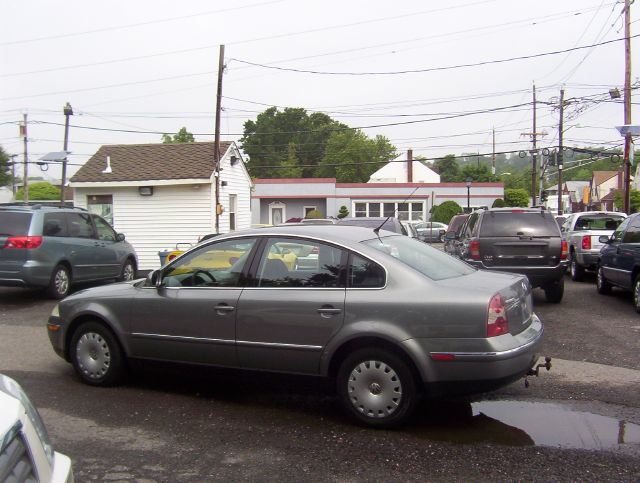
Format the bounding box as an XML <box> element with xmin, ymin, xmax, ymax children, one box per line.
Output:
<box><xmin>70</xmin><ymin>143</ymin><xmax>251</xmax><ymax>270</ymax></box>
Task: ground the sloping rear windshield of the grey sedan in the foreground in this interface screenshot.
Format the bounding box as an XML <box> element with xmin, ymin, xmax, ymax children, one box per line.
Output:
<box><xmin>362</xmin><ymin>236</ymin><xmax>476</xmax><ymax>280</ymax></box>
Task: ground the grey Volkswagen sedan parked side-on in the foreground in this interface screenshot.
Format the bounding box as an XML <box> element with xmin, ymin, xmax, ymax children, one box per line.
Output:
<box><xmin>47</xmin><ymin>224</ymin><xmax>543</xmax><ymax>427</ymax></box>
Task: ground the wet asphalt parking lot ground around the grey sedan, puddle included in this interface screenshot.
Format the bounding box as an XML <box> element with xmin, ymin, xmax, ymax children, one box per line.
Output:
<box><xmin>0</xmin><ymin>277</ymin><xmax>640</xmax><ymax>481</ymax></box>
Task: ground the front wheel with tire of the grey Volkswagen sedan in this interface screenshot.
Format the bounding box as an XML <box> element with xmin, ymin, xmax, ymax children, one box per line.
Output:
<box><xmin>69</xmin><ymin>322</ymin><xmax>125</xmax><ymax>386</ymax></box>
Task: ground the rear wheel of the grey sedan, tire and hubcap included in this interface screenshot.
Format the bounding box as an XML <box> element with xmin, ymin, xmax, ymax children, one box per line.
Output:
<box><xmin>336</xmin><ymin>348</ymin><xmax>418</xmax><ymax>428</ymax></box>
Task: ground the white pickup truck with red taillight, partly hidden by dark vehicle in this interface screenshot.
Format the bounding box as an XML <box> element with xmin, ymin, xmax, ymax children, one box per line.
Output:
<box><xmin>560</xmin><ymin>211</ymin><xmax>627</xmax><ymax>281</ymax></box>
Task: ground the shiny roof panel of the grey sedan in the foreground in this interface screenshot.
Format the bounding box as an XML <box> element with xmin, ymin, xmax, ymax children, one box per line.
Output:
<box><xmin>212</xmin><ymin>223</ymin><xmax>402</xmax><ymax>243</ymax></box>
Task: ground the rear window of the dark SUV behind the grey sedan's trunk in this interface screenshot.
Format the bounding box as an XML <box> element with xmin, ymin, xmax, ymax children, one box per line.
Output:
<box><xmin>480</xmin><ymin>211</ymin><xmax>560</xmax><ymax>237</ymax></box>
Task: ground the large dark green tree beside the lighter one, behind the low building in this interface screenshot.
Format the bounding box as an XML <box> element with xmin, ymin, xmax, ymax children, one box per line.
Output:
<box><xmin>240</xmin><ymin>107</ymin><xmax>348</xmax><ymax>178</ymax></box>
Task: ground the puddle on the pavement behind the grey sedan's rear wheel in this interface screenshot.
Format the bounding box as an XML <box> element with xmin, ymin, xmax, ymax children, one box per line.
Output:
<box><xmin>410</xmin><ymin>401</ymin><xmax>640</xmax><ymax>452</ymax></box>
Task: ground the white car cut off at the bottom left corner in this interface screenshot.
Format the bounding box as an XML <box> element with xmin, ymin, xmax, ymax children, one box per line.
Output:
<box><xmin>0</xmin><ymin>374</ymin><xmax>73</xmax><ymax>483</ymax></box>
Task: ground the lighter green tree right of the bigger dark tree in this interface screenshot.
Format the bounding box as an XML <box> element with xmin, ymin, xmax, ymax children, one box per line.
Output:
<box><xmin>314</xmin><ymin>129</ymin><xmax>397</xmax><ymax>183</ymax></box>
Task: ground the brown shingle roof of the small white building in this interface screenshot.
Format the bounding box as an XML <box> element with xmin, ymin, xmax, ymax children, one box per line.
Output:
<box><xmin>70</xmin><ymin>142</ymin><xmax>231</xmax><ymax>183</ymax></box>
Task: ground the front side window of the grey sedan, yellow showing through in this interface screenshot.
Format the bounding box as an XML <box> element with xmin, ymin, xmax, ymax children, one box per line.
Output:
<box><xmin>162</xmin><ymin>238</ymin><xmax>256</xmax><ymax>287</ymax></box>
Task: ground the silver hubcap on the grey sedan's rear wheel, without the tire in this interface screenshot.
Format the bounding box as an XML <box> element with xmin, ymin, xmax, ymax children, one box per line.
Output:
<box><xmin>347</xmin><ymin>361</ymin><xmax>402</xmax><ymax>418</ymax></box>
